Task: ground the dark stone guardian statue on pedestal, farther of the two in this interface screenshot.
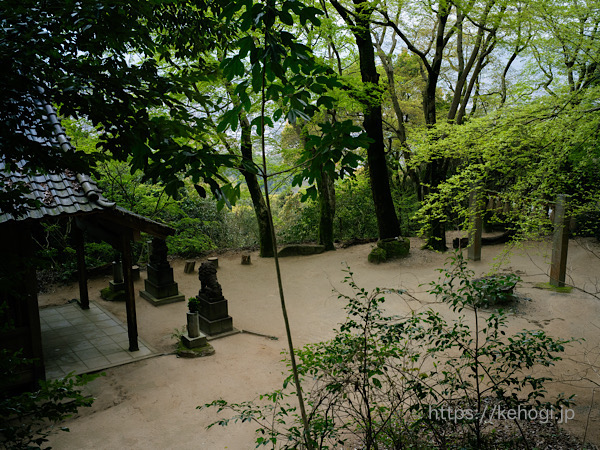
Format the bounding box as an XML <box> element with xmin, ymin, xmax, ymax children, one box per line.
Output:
<box><xmin>140</xmin><ymin>238</ymin><xmax>185</xmax><ymax>306</ymax></box>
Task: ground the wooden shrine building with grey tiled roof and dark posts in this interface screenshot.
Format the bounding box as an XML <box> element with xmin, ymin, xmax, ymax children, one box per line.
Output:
<box><xmin>0</xmin><ymin>100</ymin><xmax>175</xmax><ymax>388</ymax></box>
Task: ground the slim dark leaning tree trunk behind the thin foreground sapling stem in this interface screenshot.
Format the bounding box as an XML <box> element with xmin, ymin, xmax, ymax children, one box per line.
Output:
<box><xmin>240</xmin><ymin>115</ymin><xmax>275</xmax><ymax>258</ymax></box>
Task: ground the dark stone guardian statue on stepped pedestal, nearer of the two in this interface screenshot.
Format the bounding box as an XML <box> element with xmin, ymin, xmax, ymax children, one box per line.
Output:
<box><xmin>197</xmin><ymin>262</ymin><xmax>233</xmax><ymax>336</ymax></box>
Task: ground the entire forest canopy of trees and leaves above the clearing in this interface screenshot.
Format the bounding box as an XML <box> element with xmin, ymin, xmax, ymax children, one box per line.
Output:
<box><xmin>0</xmin><ymin>0</ymin><xmax>600</xmax><ymax>256</ymax></box>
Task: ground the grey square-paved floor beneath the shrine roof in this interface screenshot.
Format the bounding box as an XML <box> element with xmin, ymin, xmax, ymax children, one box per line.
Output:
<box><xmin>40</xmin><ymin>302</ymin><xmax>154</xmax><ymax>379</ymax></box>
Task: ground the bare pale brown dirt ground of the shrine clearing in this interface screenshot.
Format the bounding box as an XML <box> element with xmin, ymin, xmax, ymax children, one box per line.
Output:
<box><xmin>40</xmin><ymin>239</ymin><xmax>600</xmax><ymax>450</ymax></box>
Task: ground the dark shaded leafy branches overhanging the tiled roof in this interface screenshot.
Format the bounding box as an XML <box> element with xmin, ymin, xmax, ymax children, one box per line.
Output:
<box><xmin>0</xmin><ymin>0</ymin><xmax>233</xmax><ymax>214</ymax></box>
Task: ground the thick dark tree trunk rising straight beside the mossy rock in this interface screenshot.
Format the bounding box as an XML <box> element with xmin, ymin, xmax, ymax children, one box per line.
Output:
<box><xmin>331</xmin><ymin>0</ymin><xmax>400</xmax><ymax>239</ymax></box>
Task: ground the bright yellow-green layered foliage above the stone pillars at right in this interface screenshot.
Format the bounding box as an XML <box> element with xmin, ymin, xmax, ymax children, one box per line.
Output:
<box><xmin>413</xmin><ymin>87</ymin><xmax>600</xmax><ymax>243</ymax></box>
